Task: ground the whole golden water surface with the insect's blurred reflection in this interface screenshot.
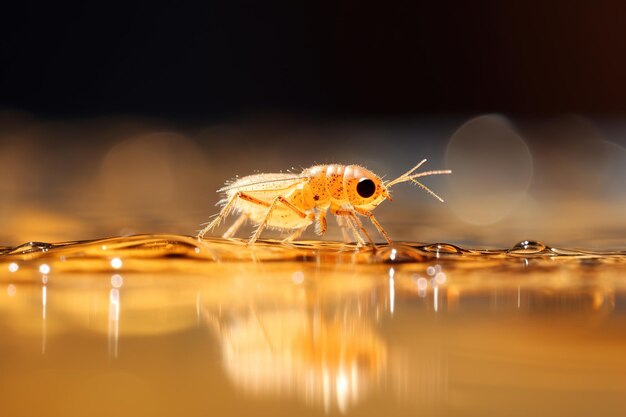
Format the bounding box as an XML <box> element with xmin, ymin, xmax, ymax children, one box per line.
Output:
<box><xmin>0</xmin><ymin>235</ymin><xmax>626</xmax><ymax>416</ymax></box>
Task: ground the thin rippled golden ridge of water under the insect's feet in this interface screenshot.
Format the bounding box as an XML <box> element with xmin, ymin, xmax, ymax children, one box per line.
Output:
<box><xmin>0</xmin><ymin>235</ymin><xmax>626</xmax><ymax>271</ymax></box>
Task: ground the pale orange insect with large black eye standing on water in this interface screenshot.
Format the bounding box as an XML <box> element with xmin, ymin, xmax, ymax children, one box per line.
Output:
<box><xmin>198</xmin><ymin>159</ymin><xmax>452</xmax><ymax>246</ymax></box>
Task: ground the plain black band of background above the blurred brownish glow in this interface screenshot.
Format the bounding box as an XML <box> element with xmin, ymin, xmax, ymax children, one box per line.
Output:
<box><xmin>0</xmin><ymin>0</ymin><xmax>626</xmax><ymax>121</ymax></box>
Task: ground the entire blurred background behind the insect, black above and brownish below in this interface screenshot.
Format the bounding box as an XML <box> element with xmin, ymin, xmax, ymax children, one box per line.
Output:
<box><xmin>0</xmin><ymin>0</ymin><xmax>626</xmax><ymax>248</ymax></box>
